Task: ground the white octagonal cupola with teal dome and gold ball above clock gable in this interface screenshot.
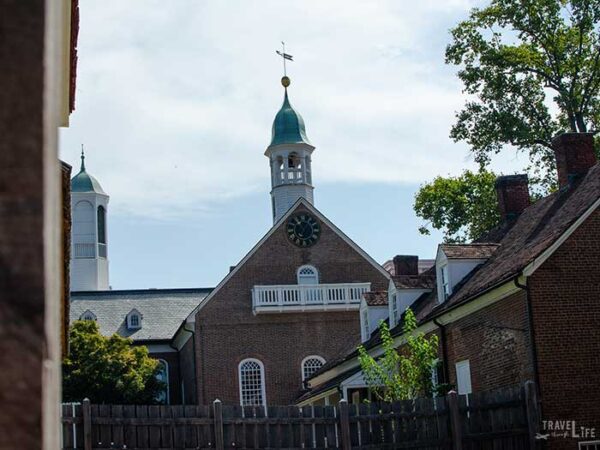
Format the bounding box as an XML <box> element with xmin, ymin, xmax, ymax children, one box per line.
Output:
<box><xmin>265</xmin><ymin>76</ymin><xmax>315</xmax><ymax>223</ymax></box>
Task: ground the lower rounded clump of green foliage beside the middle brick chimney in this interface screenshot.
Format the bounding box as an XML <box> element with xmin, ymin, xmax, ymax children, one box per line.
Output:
<box><xmin>414</xmin><ymin>170</ymin><xmax>500</xmax><ymax>242</ymax></box>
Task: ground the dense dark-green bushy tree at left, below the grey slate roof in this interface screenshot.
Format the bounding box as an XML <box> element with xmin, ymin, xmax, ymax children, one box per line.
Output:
<box><xmin>63</xmin><ymin>320</ymin><xmax>164</xmax><ymax>404</ymax></box>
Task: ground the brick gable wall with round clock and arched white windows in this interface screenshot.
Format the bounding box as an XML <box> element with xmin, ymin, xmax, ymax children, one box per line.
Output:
<box><xmin>196</xmin><ymin>206</ymin><xmax>388</xmax><ymax>404</ymax></box>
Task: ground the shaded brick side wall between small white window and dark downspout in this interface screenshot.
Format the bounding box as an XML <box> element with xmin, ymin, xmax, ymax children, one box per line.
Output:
<box><xmin>446</xmin><ymin>291</ymin><xmax>533</xmax><ymax>391</ymax></box>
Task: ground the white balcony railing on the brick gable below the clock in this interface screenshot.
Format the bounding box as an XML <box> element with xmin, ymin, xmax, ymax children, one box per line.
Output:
<box><xmin>252</xmin><ymin>283</ymin><xmax>371</xmax><ymax>313</ymax></box>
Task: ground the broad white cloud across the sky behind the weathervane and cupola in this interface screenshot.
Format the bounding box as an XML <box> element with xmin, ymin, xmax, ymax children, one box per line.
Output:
<box><xmin>61</xmin><ymin>0</ymin><xmax>518</xmax><ymax>217</ymax></box>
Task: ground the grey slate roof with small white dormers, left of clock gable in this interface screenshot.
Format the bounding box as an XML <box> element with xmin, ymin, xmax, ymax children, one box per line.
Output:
<box><xmin>70</xmin><ymin>288</ymin><xmax>212</xmax><ymax>341</ymax></box>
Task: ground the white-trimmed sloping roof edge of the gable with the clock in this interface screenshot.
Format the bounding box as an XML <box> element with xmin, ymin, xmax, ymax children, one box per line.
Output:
<box><xmin>188</xmin><ymin>197</ymin><xmax>390</xmax><ymax>320</ymax></box>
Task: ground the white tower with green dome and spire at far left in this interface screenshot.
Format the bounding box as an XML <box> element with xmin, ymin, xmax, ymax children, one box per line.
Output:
<box><xmin>71</xmin><ymin>150</ymin><xmax>109</xmax><ymax>291</ymax></box>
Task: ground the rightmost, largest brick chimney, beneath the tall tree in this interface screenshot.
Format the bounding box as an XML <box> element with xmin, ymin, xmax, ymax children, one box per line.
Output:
<box><xmin>552</xmin><ymin>133</ymin><xmax>596</xmax><ymax>188</ymax></box>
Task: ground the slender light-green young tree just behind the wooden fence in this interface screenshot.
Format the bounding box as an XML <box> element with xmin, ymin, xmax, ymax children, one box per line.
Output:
<box><xmin>358</xmin><ymin>308</ymin><xmax>438</xmax><ymax>402</ymax></box>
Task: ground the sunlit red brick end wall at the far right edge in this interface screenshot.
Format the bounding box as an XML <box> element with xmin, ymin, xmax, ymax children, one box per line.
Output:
<box><xmin>529</xmin><ymin>211</ymin><xmax>600</xmax><ymax>448</ymax></box>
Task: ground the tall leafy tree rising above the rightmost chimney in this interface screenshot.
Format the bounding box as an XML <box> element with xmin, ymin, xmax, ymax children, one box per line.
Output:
<box><xmin>446</xmin><ymin>0</ymin><xmax>600</xmax><ymax>188</ymax></box>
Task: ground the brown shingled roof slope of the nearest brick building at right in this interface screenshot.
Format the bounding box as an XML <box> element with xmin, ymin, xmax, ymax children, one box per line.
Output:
<box><xmin>433</xmin><ymin>164</ymin><xmax>600</xmax><ymax>314</ymax></box>
